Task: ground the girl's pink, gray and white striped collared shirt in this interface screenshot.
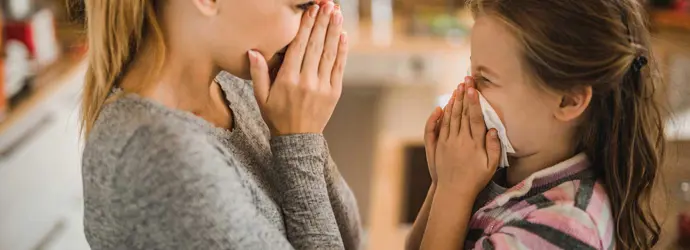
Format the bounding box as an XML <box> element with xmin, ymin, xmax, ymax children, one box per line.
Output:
<box><xmin>465</xmin><ymin>154</ymin><xmax>615</xmax><ymax>249</ymax></box>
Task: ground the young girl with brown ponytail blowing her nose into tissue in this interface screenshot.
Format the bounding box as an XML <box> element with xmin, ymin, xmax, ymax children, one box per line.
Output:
<box><xmin>408</xmin><ymin>0</ymin><xmax>664</xmax><ymax>249</ymax></box>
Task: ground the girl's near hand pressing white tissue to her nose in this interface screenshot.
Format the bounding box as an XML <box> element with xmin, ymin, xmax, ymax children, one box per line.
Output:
<box><xmin>435</xmin><ymin>77</ymin><xmax>501</xmax><ymax>197</ymax></box>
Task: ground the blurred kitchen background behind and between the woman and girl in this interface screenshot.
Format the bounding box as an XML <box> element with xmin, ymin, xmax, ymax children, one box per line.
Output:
<box><xmin>0</xmin><ymin>0</ymin><xmax>690</xmax><ymax>250</ymax></box>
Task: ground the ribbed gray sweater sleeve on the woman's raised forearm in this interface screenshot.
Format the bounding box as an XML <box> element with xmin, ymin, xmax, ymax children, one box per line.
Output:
<box><xmin>271</xmin><ymin>134</ymin><xmax>344</xmax><ymax>249</ymax></box>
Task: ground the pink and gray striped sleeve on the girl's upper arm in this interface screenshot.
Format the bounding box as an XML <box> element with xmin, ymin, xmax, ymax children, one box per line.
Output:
<box><xmin>474</xmin><ymin>205</ymin><xmax>603</xmax><ymax>249</ymax></box>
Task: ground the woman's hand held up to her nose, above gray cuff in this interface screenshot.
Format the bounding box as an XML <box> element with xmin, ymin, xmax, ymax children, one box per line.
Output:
<box><xmin>249</xmin><ymin>2</ymin><xmax>347</xmax><ymax>136</ymax></box>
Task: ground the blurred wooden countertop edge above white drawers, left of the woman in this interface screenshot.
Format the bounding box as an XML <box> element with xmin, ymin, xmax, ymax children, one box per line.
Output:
<box><xmin>0</xmin><ymin>56</ymin><xmax>83</xmax><ymax>158</ymax></box>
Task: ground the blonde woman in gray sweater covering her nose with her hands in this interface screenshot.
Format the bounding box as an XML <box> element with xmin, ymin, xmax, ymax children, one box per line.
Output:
<box><xmin>78</xmin><ymin>0</ymin><xmax>360</xmax><ymax>249</ymax></box>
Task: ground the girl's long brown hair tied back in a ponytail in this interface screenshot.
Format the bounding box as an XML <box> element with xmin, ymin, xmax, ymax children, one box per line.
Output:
<box><xmin>469</xmin><ymin>0</ymin><xmax>665</xmax><ymax>249</ymax></box>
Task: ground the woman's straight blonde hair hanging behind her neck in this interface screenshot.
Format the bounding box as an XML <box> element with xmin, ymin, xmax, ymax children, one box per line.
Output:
<box><xmin>79</xmin><ymin>0</ymin><xmax>165</xmax><ymax>137</ymax></box>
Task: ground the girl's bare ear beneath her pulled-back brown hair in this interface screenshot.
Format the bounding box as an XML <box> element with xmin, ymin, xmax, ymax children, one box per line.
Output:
<box><xmin>554</xmin><ymin>86</ymin><xmax>592</xmax><ymax>122</ymax></box>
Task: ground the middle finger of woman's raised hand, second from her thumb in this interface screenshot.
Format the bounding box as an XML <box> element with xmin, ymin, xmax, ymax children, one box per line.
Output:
<box><xmin>302</xmin><ymin>2</ymin><xmax>334</xmax><ymax>78</ymax></box>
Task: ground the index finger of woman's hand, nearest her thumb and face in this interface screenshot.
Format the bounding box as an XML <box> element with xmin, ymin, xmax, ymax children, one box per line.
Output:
<box><xmin>278</xmin><ymin>4</ymin><xmax>319</xmax><ymax>77</ymax></box>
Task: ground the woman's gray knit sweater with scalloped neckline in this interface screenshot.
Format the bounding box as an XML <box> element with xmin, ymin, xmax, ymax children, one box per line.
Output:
<box><xmin>82</xmin><ymin>73</ymin><xmax>361</xmax><ymax>249</ymax></box>
